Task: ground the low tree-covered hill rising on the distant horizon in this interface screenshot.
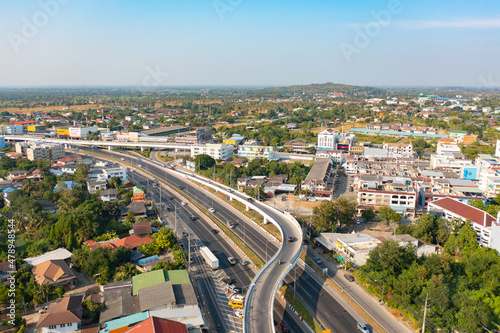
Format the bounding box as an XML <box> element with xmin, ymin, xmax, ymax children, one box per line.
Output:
<box><xmin>254</xmin><ymin>82</ymin><xmax>387</xmax><ymax>97</ymax></box>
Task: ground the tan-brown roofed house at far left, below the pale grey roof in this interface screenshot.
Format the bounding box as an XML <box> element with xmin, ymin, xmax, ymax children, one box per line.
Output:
<box><xmin>32</xmin><ymin>259</ymin><xmax>76</xmax><ymax>286</ymax></box>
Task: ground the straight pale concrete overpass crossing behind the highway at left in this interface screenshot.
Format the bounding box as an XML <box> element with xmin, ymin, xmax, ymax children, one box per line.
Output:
<box><xmin>4</xmin><ymin>135</ymin><xmax>191</xmax><ymax>151</ymax></box>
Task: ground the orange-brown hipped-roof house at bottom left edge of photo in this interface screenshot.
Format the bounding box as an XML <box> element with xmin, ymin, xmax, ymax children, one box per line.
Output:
<box><xmin>36</xmin><ymin>296</ymin><xmax>83</xmax><ymax>333</ymax></box>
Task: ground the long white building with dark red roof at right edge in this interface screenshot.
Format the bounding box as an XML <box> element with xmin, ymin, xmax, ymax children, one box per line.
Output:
<box><xmin>429</xmin><ymin>198</ymin><xmax>500</xmax><ymax>251</ymax></box>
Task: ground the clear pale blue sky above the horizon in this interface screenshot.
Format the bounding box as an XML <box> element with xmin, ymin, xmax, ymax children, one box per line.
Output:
<box><xmin>0</xmin><ymin>0</ymin><xmax>500</xmax><ymax>87</ymax></box>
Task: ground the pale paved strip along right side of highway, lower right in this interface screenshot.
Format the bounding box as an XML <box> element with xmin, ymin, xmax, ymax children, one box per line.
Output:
<box><xmin>307</xmin><ymin>246</ymin><xmax>413</xmax><ymax>333</ymax></box>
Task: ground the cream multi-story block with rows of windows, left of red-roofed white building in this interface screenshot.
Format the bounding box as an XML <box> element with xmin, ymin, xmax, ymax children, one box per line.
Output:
<box><xmin>357</xmin><ymin>175</ymin><xmax>418</xmax><ymax>216</ymax></box>
